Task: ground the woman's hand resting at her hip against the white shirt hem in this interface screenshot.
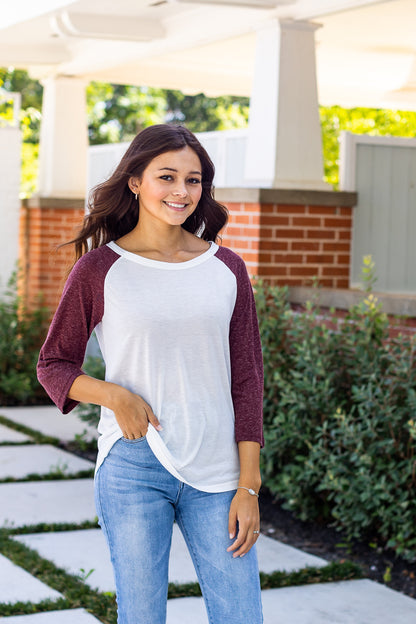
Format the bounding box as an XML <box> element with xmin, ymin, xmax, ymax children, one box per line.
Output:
<box><xmin>111</xmin><ymin>386</ymin><xmax>162</xmax><ymax>440</ymax></box>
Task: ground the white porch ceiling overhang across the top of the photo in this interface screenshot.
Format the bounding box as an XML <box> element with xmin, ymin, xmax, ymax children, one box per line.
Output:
<box><xmin>0</xmin><ymin>0</ymin><xmax>416</xmax><ymax>110</ymax></box>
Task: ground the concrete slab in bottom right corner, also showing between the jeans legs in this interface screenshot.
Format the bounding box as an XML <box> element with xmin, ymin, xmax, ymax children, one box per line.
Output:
<box><xmin>167</xmin><ymin>580</ymin><xmax>416</xmax><ymax>624</ymax></box>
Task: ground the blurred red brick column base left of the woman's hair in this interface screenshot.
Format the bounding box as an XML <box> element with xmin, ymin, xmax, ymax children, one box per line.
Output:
<box><xmin>20</xmin><ymin>197</ymin><xmax>84</xmax><ymax>314</ymax></box>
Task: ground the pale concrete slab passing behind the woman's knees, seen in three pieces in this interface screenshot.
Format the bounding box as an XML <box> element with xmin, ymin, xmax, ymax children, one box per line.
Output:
<box><xmin>14</xmin><ymin>524</ymin><xmax>327</xmax><ymax>591</ymax></box>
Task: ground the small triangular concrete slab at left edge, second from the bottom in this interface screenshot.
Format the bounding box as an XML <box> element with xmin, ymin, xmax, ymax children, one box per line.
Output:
<box><xmin>0</xmin><ymin>555</ymin><xmax>62</xmax><ymax>604</ymax></box>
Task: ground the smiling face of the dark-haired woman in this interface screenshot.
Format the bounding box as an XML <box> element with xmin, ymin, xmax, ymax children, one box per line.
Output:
<box><xmin>129</xmin><ymin>146</ymin><xmax>202</xmax><ymax>225</ymax></box>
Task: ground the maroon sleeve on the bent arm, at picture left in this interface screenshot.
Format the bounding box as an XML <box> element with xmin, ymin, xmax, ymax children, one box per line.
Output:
<box><xmin>37</xmin><ymin>246</ymin><xmax>119</xmax><ymax>414</ymax></box>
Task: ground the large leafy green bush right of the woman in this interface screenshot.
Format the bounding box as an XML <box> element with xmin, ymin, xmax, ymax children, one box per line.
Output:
<box><xmin>256</xmin><ymin>278</ymin><xmax>416</xmax><ymax>559</ymax></box>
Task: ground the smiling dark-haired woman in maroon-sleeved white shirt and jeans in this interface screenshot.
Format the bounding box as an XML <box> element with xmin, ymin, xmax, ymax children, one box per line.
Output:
<box><xmin>38</xmin><ymin>125</ymin><xmax>263</xmax><ymax>624</ymax></box>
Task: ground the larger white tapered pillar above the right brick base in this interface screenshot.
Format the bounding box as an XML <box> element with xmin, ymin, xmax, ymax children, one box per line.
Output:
<box><xmin>246</xmin><ymin>20</ymin><xmax>330</xmax><ymax>190</ymax></box>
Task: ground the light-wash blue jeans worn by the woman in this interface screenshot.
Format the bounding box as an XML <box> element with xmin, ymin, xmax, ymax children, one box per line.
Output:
<box><xmin>95</xmin><ymin>438</ymin><xmax>263</xmax><ymax>624</ymax></box>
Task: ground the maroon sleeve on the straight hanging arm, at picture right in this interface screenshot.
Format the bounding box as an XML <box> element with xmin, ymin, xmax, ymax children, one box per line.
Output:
<box><xmin>216</xmin><ymin>247</ymin><xmax>264</xmax><ymax>446</ymax></box>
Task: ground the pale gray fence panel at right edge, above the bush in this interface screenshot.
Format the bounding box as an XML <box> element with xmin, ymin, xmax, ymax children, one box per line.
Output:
<box><xmin>341</xmin><ymin>133</ymin><xmax>416</xmax><ymax>294</ymax></box>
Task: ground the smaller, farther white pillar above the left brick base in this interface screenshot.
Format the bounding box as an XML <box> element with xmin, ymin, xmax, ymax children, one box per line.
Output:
<box><xmin>39</xmin><ymin>76</ymin><xmax>88</xmax><ymax>198</ymax></box>
